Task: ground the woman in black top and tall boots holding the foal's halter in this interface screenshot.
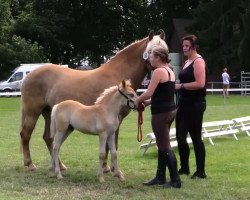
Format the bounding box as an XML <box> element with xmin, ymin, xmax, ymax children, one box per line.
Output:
<box><xmin>135</xmin><ymin>47</ymin><xmax>181</xmax><ymax>188</ymax></box>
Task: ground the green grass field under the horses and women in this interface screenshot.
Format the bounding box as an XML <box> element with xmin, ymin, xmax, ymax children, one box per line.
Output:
<box><xmin>0</xmin><ymin>95</ymin><xmax>250</xmax><ymax>200</ymax></box>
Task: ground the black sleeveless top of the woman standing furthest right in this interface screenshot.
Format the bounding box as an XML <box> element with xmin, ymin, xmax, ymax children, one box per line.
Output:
<box><xmin>179</xmin><ymin>57</ymin><xmax>206</xmax><ymax>101</ymax></box>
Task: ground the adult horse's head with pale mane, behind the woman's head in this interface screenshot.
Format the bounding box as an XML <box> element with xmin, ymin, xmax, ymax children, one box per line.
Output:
<box><xmin>143</xmin><ymin>29</ymin><xmax>169</xmax><ymax>70</ymax></box>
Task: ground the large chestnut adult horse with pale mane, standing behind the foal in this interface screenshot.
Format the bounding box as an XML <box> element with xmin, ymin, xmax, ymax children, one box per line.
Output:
<box><xmin>20</xmin><ymin>28</ymin><xmax>168</xmax><ymax>171</ymax></box>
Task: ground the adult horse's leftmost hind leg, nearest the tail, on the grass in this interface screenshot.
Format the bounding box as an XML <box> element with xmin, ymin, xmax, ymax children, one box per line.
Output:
<box><xmin>20</xmin><ymin>115</ymin><xmax>38</xmax><ymax>171</ymax></box>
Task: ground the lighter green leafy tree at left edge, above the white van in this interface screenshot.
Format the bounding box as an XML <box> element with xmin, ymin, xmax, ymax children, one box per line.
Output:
<box><xmin>0</xmin><ymin>0</ymin><xmax>43</xmax><ymax>79</ymax></box>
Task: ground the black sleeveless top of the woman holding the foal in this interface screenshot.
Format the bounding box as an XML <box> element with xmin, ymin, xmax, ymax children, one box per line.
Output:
<box><xmin>151</xmin><ymin>69</ymin><xmax>176</xmax><ymax>114</ymax></box>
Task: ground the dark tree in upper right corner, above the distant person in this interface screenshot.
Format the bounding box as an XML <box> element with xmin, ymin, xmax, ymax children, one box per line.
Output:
<box><xmin>189</xmin><ymin>0</ymin><xmax>250</xmax><ymax>76</ymax></box>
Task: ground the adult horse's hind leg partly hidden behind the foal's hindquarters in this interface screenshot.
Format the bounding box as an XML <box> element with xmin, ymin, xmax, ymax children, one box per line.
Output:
<box><xmin>42</xmin><ymin>107</ymin><xmax>67</xmax><ymax>170</ymax></box>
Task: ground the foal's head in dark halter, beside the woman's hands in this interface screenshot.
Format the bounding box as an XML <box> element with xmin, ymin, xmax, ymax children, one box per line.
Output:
<box><xmin>118</xmin><ymin>80</ymin><xmax>137</xmax><ymax>109</ymax></box>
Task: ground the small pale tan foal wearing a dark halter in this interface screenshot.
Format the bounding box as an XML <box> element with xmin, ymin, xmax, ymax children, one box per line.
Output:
<box><xmin>50</xmin><ymin>81</ymin><xmax>136</xmax><ymax>182</ymax></box>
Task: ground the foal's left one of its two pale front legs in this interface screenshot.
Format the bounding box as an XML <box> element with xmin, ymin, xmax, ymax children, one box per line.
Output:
<box><xmin>97</xmin><ymin>132</ymin><xmax>107</xmax><ymax>182</ymax></box>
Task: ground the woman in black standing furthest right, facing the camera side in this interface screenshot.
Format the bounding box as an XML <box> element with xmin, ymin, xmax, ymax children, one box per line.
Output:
<box><xmin>175</xmin><ymin>35</ymin><xmax>207</xmax><ymax>179</ymax></box>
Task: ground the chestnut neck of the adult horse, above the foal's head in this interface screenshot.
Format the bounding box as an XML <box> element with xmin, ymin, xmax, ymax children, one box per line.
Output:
<box><xmin>100</xmin><ymin>39</ymin><xmax>147</xmax><ymax>89</ymax></box>
